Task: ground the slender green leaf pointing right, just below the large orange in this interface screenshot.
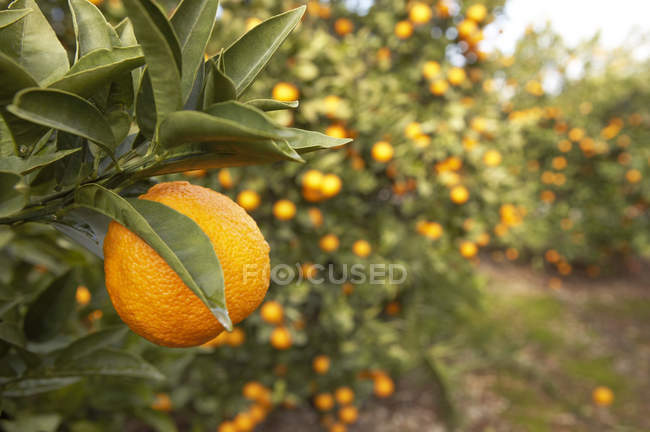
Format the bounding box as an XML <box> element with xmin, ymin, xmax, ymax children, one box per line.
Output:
<box><xmin>54</xmin><ymin>348</ymin><xmax>165</xmax><ymax>381</ymax></box>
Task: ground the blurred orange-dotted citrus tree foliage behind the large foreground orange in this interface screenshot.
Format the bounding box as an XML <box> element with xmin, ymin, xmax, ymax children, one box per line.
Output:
<box><xmin>0</xmin><ymin>0</ymin><xmax>650</xmax><ymax>432</ymax></box>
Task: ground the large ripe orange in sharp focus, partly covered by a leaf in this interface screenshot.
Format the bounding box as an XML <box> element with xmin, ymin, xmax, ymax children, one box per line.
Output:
<box><xmin>104</xmin><ymin>181</ymin><xmax>270</xmax><ymax>347</ymax></box>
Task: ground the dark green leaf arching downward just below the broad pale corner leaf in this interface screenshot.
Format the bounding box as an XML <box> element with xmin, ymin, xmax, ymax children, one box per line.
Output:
<box><xmin>7</xmin><ymin>89</ymin><xmax>116</xmax><ymax>154</ymax></box>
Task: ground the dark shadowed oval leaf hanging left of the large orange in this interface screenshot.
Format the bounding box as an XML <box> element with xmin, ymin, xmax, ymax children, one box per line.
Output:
<box><xmin>23</xmin><ymin>271</ymin><xmax>77</xmax><ymax>342</ymax></box>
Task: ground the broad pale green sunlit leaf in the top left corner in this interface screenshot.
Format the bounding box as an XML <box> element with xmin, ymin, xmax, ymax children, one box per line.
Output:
<box><xmin>0</xmin><ymin>0</ymin><xmax>70</xmax><ymax>85</ymax></box>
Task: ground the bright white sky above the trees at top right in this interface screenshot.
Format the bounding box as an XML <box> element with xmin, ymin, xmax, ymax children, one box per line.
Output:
<box><xmin>486</xmin><ymin>0</ymin><xmax>650</xmax><ymax>58</ymax></box>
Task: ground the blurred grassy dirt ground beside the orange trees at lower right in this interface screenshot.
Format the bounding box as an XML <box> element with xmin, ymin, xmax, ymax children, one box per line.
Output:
<box><xmin>259</xmin><ymin>263</ymin><xmax>650</xmax><ymax>432</ymax></box>
